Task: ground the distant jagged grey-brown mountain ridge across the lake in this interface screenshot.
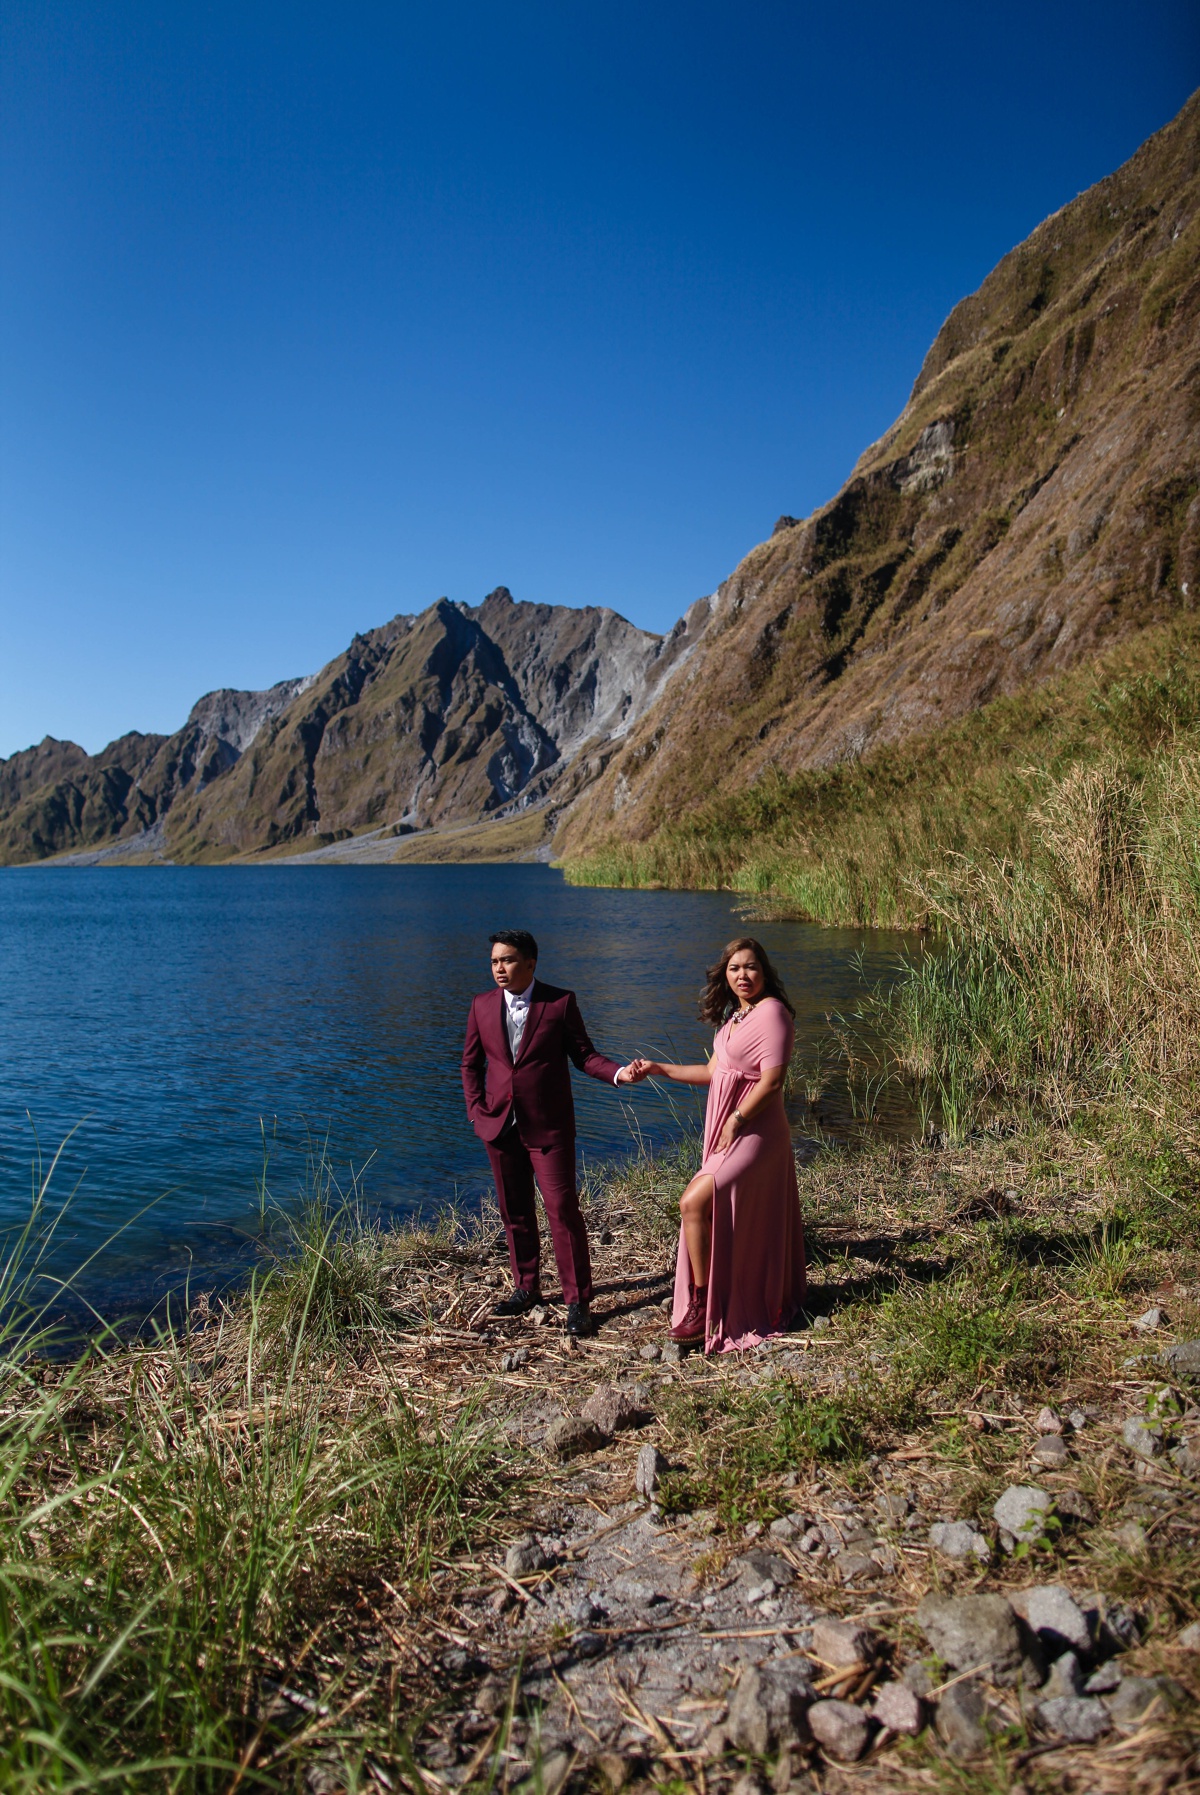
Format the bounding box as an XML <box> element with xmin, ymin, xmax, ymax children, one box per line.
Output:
<box><xmin>0</xmin><ymin>587</ymin><xmax>707</xmax><ymax>863</ymax></box>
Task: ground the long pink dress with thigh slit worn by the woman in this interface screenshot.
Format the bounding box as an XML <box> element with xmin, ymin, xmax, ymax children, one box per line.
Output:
<box><xmin>671</xmin><ymin>998</ymin><xmax>805</xmax><ymax>1352</ymax></box>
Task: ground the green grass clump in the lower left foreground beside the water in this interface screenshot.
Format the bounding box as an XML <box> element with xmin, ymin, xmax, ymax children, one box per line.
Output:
<box><xmin>0</xmin><ymin>1155</ymin><xmax>511</xmax><ymax>1791</ymax></box>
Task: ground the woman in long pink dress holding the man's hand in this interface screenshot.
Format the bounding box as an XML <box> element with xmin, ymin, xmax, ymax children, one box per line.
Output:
<box><xmin>631</xmin><ymin>937</ymin><xmax>805</xmax><ymax>1352</ymax></box>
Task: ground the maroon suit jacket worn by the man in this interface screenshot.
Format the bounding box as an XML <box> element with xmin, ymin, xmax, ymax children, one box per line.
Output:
<box><xmin>463</xmin><ymin>978</ymin><xmax>621</xmax><ymax>1147</ymax></box>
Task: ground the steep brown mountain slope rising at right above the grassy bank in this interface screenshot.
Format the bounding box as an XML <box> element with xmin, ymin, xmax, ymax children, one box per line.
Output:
<box><xmin>556</xmin><ymin>97</ymin><xmax>1200</xmax><ymax>858</ymax></box>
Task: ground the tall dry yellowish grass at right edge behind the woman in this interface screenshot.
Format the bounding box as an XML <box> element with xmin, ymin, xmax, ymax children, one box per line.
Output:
<box><xmin>879</xmin><ymin>745</ymin><xmax>1200</xmax><ymax>1149</ymax></box>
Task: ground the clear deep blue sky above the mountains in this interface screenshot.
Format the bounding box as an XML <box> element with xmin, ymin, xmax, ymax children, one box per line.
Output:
<box><xmin>0</xmin><ymin>0</ymin><xmax>1200</xmax><ymax>754</ymax></box>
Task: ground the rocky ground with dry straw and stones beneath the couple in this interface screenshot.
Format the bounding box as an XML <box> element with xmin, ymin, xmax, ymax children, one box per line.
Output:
<box><xmin>315</xmin><ymin>1140</ymin><xmax>1200</xmax><ymax>1795</ymax></box>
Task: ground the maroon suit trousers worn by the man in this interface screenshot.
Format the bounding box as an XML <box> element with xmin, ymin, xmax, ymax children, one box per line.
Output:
<box><xmin>486</xmin><ymin>1125</ymin><xmax>592</xmax><ymax>1303</ymax></box>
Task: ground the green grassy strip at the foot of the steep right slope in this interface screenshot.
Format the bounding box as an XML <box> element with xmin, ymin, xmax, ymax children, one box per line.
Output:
<box><xmin>563</xmin><ymin>617</ymin><xmax>1200</xmax><ymax>928</ymax></box>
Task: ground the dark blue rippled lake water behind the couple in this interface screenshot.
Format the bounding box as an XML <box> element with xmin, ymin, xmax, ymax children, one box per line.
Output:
<box><xmin>0</xmin><ymin>865</ymin><xmax>906</xmax><ymax>1312</ymax></box>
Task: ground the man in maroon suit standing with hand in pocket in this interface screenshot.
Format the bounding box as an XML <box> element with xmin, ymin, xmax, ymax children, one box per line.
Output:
<box><xmin>463</xmin><ymin>928</ymin><xmax>637</xmax><ymax>1335</ymax></box>
